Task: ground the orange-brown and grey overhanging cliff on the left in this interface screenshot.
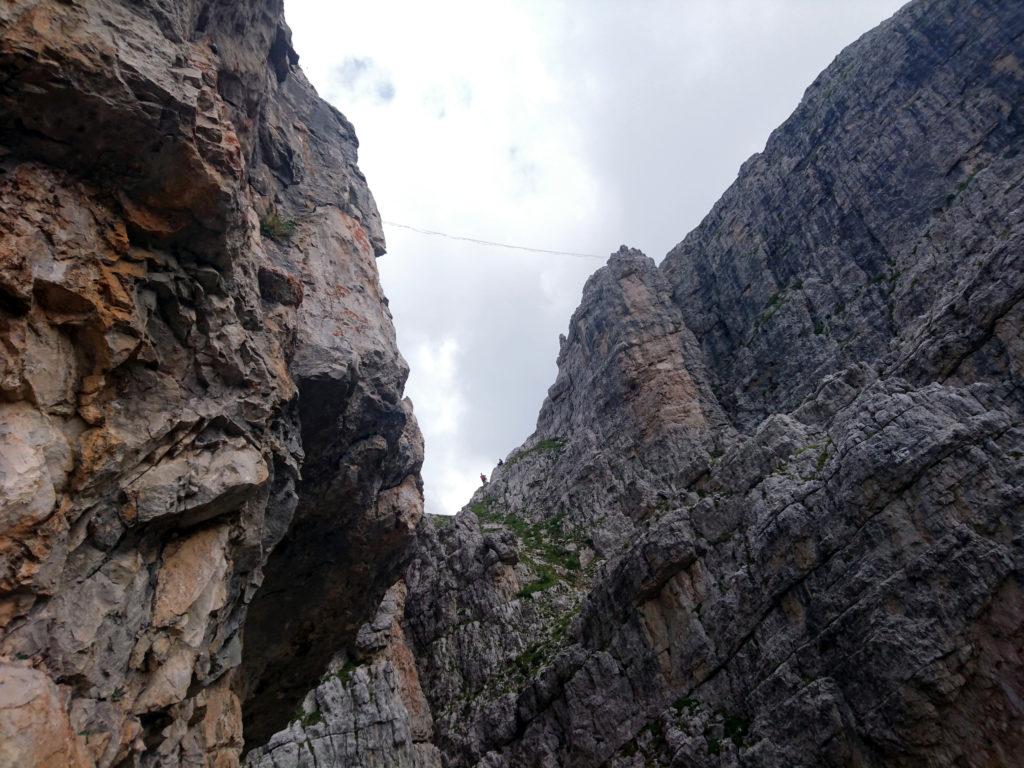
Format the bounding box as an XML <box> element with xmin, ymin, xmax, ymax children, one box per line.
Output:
<box><xmin>0</xmin><ymin>0</ymin><xmax>422</xmax><ymax>768</ymax></box>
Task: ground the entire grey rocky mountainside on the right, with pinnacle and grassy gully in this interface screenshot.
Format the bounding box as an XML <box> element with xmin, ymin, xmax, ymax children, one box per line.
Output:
<box><xmin>249</xmin><ymin>0</ymin><xmax>1024</xmax><ymax>768</ymax></box>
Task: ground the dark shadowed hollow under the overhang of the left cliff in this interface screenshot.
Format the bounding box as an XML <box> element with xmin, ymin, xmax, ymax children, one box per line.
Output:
<box><xmin>235</xmin><ymin>378</ymin><xmax>408</xmax><ymax>750</ymax></box>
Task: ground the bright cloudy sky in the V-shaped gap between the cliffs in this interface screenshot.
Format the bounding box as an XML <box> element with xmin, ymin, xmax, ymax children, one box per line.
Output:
<box><xmin>286</xmin><ymin>0</ymin><xmax>902</xmax><ymax>514</ymax></box>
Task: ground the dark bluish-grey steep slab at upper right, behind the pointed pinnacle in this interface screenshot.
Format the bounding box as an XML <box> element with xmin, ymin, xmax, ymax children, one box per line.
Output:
<box><xmin>663</xmin><ymin>0</ymin><xmax>1024</xmax><ymax>428</ymax></box>
